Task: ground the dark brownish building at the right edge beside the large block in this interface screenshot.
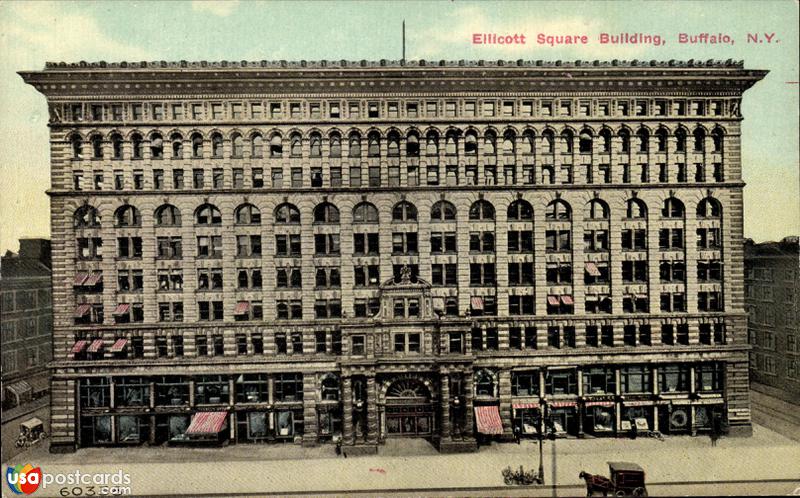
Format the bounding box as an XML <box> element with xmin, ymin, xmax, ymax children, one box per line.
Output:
<box><xmin>744</xmin><ymin>237</ymin><xmax>800</xmax><ymax>402</ymax></box>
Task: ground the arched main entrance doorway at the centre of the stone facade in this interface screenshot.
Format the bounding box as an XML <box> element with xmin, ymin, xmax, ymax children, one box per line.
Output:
<box><xmin>384</xmin><ymin>378</ymin><xmax>434</xmax><ymax>437</ymax></box>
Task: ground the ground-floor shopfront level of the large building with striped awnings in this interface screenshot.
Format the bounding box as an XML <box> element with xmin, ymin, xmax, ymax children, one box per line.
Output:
<box><xmin>53</xmin><ymin>354</ymin><xmax>752</xmax><ymax>451</ymax></box>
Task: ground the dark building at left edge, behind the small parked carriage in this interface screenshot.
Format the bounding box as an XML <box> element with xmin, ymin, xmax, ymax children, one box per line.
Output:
<box><xmin>0</xmin><ymin>239</ymin><xmax>53</xmax><ymax>410</ymax></box>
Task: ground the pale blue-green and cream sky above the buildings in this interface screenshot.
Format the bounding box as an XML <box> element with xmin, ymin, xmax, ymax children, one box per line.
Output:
<box><xmin>0</xmin><ymin>0</ymin><xmax>800</xmax><ymax>252</ymax></box>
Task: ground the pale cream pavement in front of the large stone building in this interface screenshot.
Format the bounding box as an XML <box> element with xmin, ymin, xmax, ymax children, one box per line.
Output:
<box><xmin>3</xmin><ymin>426</ymin><xmax>800</xmax><ymax>496</ymax></box>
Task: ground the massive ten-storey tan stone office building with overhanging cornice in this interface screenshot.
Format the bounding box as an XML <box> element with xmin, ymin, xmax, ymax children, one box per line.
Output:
<box><xmin>21</xmin><ymin>56</ymin><xmax>766</xmax><ymax>452</ymax></box>
